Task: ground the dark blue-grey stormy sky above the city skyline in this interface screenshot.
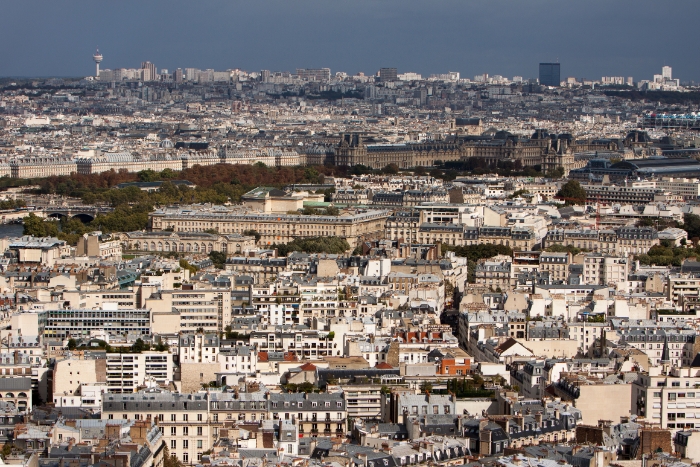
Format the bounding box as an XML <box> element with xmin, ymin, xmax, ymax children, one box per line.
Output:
<box><xmin>0</xmin><ymin>0</ymin><xmax>700</xmax><ymax>81</ymax></box>
